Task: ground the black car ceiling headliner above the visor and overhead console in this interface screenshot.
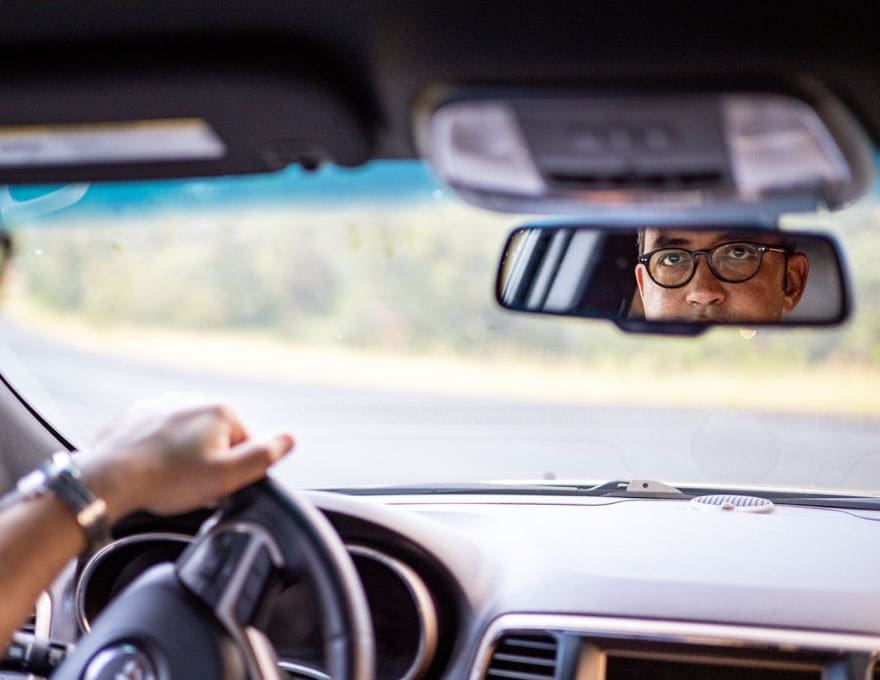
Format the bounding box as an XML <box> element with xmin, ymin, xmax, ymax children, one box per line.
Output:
<box><xmin>0</xmin><ymin>0</ymin><xmax>880</xmax><ymax>166</ymax></box>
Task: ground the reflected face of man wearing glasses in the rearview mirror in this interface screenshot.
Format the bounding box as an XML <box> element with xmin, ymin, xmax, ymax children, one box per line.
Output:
<box><xmin>635</xmin><ymin>229</ymin><xmax>809</xmax><ymax>323</ymax></box>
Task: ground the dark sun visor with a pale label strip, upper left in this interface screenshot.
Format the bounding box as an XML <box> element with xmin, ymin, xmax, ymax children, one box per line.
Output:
<box><xmin>0</xmin><ymin>46</ymin><xmax>374</xmax><ymax>184</ymax></box>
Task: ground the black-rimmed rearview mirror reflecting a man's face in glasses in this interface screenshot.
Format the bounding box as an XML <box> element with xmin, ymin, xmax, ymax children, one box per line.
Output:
<box><xmin>496</xmin><ymin>225</ymin><xmax>850</xmax><ymax>335</ymax></box>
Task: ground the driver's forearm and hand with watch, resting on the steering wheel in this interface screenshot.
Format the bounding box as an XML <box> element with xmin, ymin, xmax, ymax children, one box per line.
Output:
<box><xmin>0</xmin><ymin>403</ymin><xmax>293</xmax><ymax>649</ymax></box>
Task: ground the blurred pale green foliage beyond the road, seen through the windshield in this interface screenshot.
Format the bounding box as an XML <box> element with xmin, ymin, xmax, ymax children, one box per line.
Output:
<box><xmin>5</xmin><ymin>193</ymin><xmax>880</xmax><ymax>374</ymax></box>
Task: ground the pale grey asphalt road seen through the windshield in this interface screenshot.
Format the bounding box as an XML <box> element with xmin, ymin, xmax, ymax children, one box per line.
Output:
<box><xmin>0</xmin><ymin>320</ymin><xmax>880</xmax><ymax>488</ymax></box>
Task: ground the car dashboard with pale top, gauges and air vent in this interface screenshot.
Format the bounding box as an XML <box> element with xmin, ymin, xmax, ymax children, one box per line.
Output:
<box><xmin>18</xmin><ymin>492</ymin><xmax>880</xmax><ymax>680</ymax></box>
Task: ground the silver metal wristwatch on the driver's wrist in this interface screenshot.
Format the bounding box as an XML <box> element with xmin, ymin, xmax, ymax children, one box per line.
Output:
<box><xmin>16</xmin><ymin>451</ymin><xmax>110</xmax><ymax>553</ymax></box>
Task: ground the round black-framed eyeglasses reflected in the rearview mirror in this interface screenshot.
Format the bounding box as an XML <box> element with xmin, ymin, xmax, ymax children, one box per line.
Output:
<box><xmin>639</xmin><ymin>241</ymin><xmax>790</xmax><ymax>288</ymax></box>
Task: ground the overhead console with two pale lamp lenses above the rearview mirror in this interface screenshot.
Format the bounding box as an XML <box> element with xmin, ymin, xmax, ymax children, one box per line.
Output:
<box><xmin>416</xmin><ymin>82</ymin><xmax>874</xmax><ymax>225</ymax></box>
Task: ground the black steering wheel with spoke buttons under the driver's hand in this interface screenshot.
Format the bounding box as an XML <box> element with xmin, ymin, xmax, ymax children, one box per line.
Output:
<box><xmin>52</xmin><ymin>479</ymin><xmax>375</xmax><ymax>680</ymax></box>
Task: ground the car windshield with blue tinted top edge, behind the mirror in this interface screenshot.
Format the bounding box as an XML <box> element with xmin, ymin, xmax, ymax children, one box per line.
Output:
<box><xmin>0</xmin><ymin>162</ymin><xmax>880</xmax><ymax>493</ymax></box>
